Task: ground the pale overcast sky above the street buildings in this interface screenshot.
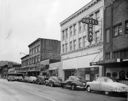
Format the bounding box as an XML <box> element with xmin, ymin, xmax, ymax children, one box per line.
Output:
<box><xmin>0</xmin><ymin>0</ymin><xmax>91</xmax><ymax>63</ymax></box>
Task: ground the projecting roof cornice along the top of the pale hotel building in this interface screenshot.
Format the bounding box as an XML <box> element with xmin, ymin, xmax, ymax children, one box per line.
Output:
<box><xmin>60</xmin><ymin>0</ymin><xmax>102</xmax><ymax>26</ymax></box>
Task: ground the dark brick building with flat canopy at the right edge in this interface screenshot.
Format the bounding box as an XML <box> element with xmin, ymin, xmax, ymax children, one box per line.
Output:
<box><xmin>102</xmin><ymin>0</ymin><xmax>128</xmax><ymax>80</ymax></box>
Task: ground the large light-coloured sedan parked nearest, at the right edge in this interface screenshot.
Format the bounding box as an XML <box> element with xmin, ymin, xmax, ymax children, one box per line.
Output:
<box><xmin>87</xmin><ymin>77</ymin><xmax>128</xmax><ymax>94</ymax></box>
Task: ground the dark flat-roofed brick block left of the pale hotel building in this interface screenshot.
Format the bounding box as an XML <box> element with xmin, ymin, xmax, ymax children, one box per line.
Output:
<box><xmin>21</xmin><ymin>38</ymin><xmax>60</xmax><ymax>75</ymax></box>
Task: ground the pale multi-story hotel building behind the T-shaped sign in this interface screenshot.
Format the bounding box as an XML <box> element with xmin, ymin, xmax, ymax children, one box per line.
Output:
<box><xmin>60</xmin><ymin>0</ymin><xmax>104</xmax><ymax>80</ymax></box>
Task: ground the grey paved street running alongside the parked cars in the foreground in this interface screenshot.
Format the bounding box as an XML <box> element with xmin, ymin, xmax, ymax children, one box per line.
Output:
<box><xmin>0</xmin><ymin>79</ymin><xmax>127</xmax><ymax>101</ymax></box>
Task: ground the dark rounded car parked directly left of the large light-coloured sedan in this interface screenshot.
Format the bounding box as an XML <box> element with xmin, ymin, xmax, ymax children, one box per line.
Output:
<box><xmin>61</xmin><ymin>76</ymin><xmax>86</xmax><ymax>90</ymax></box>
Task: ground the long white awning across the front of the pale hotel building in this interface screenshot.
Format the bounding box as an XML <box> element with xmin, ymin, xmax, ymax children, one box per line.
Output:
<box><xmin>62</xmin><ymin>53</ymin><xmax>103</xmax><ymax>69</ymax></box>
